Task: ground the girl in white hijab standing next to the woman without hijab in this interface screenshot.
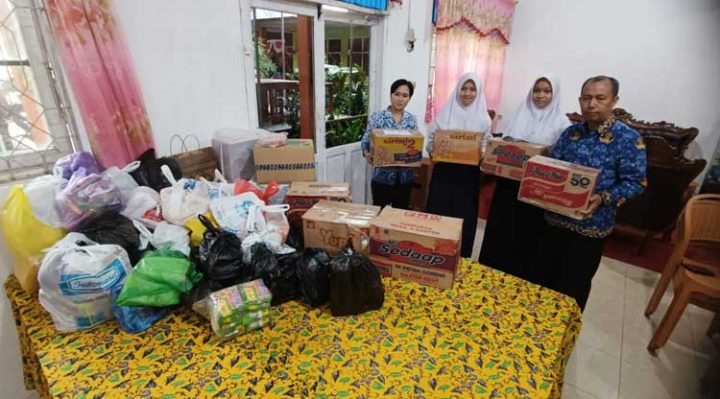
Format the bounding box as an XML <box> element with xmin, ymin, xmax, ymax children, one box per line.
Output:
<box><xmin>426</xmin><ymin>73</ymin><xmax>491</xmax><ymax>258</ymax></box>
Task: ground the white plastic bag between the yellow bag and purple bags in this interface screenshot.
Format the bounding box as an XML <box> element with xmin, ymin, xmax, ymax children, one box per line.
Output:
<box><xmin>23</xmin><ymin>173</ymin><xmax>67</xmax><ymax>228</ymax></box>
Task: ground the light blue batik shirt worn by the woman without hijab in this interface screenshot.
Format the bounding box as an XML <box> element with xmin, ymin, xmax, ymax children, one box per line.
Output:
<box><xmin>360</xmin><ymin>109</ymin><xmax>417</xmax><ymax>186</ymax></box>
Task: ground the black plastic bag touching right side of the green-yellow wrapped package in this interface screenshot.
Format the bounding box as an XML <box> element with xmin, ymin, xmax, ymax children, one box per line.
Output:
<box><xmin>250</xmin><ymin>243</ymin><xmax>300</xmax><ymax>306</ymax></box>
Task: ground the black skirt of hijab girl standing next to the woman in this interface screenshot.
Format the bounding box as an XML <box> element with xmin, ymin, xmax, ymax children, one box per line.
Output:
<box><xmin>426</xmin><ymin>162</ymin><xmax>480</xmax><ymax>258</ymax></box>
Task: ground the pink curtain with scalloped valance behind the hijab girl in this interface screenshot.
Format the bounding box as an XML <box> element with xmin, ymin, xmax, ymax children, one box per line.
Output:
<box><xmin>425</xmin><ymin>0</ymin><xmax>516</xmax><ymax>122</ymax></box>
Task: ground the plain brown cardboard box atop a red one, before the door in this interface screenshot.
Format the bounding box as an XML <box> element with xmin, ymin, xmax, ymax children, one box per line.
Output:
<box><xmin>253</xmin><ymin>139</ymin><xmax>315</xmax><ymax>183</ymax></box>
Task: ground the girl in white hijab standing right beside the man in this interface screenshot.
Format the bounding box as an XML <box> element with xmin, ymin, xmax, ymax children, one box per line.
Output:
<box><xmin>479</xmin><ymin>75</ymin><xmax>570</xmax><ymax>283</ymax></box>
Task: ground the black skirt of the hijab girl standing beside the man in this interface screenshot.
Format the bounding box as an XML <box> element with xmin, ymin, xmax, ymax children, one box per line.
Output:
<box><xmin>479</xmin><ymin>178</ymin><xmax>545</xmax><ymax>283</ymax></box>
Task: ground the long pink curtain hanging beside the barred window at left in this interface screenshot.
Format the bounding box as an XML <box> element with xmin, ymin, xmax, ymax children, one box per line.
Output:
<box><xmin>47</xmin><ymin>0</ymin><xmax>154</xmax><ymax>168</ymax></box>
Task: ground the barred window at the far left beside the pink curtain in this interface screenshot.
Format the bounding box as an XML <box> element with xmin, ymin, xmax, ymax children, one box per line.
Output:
<box><xmin>0</xmin><ymin>0</ymin><xmax>77</xmax><ymax>183</ymax></box>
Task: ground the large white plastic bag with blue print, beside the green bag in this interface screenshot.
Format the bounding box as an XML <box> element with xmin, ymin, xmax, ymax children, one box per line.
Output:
<box><xmin>38</xmin><ymin>233</ymin><xmax>132</xmax><ymax>332</ymax></box>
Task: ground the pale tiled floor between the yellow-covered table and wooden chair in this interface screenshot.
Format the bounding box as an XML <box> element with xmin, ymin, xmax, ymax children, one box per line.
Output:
<box><xmin>473</xmin><ymin>220</ymin><xmax>720</xmax><ymax>399</ymax></box>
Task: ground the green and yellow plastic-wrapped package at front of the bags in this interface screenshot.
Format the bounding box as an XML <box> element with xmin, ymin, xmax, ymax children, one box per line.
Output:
<box><xmin>208</xmin><ymin>280</ymin><xmax>272</xmax><ymax>338</ymax></box>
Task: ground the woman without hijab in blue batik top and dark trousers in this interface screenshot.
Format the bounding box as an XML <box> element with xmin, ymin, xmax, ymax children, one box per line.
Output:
<box><xmin>361</xmin><ymin>79</ymin><xmax>417</xmax><ymax>209</ymax></box>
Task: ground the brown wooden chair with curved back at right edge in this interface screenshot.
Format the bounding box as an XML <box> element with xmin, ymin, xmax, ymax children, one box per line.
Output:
<box><xmin>645</xmin><ymin>194</ymin><xmax>720</xmax><ymax>354</ymax></box>
